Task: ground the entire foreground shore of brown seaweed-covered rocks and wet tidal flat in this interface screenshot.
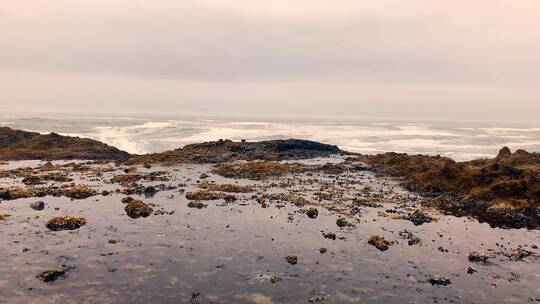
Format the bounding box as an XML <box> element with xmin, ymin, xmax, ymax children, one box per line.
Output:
<box><xmin>0</xmin><ymin>130</ymin><xmax>540</xmax><ymax>304</ymax></box>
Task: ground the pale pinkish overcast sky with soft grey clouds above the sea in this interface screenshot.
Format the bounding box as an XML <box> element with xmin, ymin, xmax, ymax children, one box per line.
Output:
<box><xmin>0</xmin><ymin>0</ymin><xmax>540</xmax><ymax>121</ymax></box>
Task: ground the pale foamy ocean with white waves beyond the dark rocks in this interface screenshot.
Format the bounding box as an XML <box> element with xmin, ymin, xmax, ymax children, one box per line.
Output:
<box><xmin>0</xmin><ymin>114</ymin><xmax>540</xmax><ymax>161</ymax></box>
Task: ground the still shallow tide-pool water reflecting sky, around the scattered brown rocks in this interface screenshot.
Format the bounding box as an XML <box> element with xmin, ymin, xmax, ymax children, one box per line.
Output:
<box><xmin>0</xmin><ymin>160</ymin><xmax>540</xmax><ymax>303</ymax></box>
